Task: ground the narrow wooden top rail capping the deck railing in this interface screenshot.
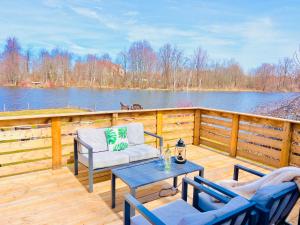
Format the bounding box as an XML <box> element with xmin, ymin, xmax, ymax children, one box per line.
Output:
<box><xmin>0</xmin><ymin>107</ymin><xmax>300</xmax><ymax>124</ymax></box>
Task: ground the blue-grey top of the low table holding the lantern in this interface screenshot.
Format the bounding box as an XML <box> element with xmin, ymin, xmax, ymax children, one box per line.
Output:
<box><xmin>112</xmin><ymin>158</ymin><xmax>203</xmax><ymax>188</ymax></box>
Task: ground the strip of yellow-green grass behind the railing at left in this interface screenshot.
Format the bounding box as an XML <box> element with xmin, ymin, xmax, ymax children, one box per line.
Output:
<box><xmin>0</xmin><ymin>108</ymin><xmax>87</xmax><ymax>117</ymax></box>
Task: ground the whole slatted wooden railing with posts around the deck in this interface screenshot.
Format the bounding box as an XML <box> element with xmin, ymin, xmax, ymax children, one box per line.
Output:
<box><xmin>0</xmin><ymin>107</ymin><xmax>300</xmax><ymax>177</ymax></box>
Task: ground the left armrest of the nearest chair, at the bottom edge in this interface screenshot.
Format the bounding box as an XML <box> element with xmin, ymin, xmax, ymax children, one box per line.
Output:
<box><xmin>124</xmin><ymin>194</ymin><xmax>166</xmax><ymax>225</ymax></box>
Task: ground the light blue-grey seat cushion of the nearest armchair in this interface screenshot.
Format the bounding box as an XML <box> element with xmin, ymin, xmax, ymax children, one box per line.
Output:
<box><xmin>131</xmin><ymin>199</ymin><xmax>199</xmax><ymax>225</ymax></box>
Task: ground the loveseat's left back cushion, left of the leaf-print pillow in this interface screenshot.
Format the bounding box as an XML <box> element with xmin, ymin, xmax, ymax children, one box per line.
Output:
<box><xmin>77</xmin><ymin>128</ymin><xmax>108</xmax><ymax>153</ymax></box>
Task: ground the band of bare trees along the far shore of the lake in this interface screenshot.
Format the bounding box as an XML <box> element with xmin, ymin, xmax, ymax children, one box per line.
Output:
<box><xmin>0</xmin><ymin>37</ymin><xmax>300</xmax><ymax>91</ymax></box>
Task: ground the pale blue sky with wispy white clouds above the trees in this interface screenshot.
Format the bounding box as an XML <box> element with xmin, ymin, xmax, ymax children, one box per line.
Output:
<box><xmin>0</xmin><ymin>0</ymin><xmax>300</xmax><ymax>69</ymax></box>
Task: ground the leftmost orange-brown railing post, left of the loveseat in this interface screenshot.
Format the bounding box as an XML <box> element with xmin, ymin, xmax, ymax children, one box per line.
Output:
<box><xmin>51</xmin><ymin>117</ymin><xmax>62</xmax><ymax>169</ymax></box>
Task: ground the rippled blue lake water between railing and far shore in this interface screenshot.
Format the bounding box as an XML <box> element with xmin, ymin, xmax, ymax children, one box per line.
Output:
<box><xmin>0</xmin><ymin>87</ymin><xmax>299</xmax><ymax>112</ymax></box>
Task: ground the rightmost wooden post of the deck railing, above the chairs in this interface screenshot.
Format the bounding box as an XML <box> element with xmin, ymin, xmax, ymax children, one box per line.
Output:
<box><xmin>280</xmin><ymin>122</ymin><xmax>292</xmax><ymax>167</ymax></box>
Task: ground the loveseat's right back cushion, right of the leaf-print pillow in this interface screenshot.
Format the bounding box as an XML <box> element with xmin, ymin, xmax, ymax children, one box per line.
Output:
<box><xmin>115</xmin><ymin>123</ymin><xmax>145</xmax><ymax>145</ymax></box>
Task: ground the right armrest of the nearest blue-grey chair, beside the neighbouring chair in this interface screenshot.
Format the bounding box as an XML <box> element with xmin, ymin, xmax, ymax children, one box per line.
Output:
<box><xmin>182</xmin><ymin>178</ymin><xmax>231</xmax><ymax>203</ymax></box>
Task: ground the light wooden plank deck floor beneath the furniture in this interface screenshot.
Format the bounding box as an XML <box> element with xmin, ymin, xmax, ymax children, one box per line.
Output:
<box><xmin>0</xmin><ymin>146</ymin><xmax>299</xmax><ymax>225</ymax></box>
